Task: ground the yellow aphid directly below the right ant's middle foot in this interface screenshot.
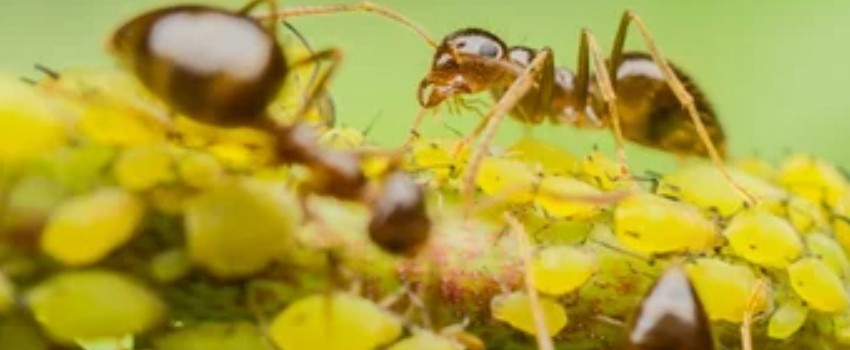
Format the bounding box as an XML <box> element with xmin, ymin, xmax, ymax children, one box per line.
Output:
<box><xmin>534</xmin><ymin>176</ymin><xmax>604</xmax><ymax>219</ymax></box>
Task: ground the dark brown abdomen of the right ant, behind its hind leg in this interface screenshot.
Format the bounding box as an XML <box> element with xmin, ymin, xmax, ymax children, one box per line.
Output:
<box><xmin>604</xmin><ymin>52</ymin><xmax>726</xmax><ymax>157</ymax></box>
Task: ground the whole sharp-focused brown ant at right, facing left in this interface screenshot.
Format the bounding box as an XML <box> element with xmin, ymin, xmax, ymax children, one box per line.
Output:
<box><xmin>405</xmin><ymin>11</ymin><xmax>756</xmax><ymax>211</ymax></box>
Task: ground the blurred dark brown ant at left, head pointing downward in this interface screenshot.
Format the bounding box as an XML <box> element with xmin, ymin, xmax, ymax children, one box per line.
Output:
<box><xmin>109</xmin><ymin>0</ymin><xmax>431</xmax><ymax>256</ymax></box>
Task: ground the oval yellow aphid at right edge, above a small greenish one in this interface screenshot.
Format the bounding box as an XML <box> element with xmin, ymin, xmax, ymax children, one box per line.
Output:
<box><xmin>788</xmin><ymin>258</ymin><xmax>848</xmax><ymax>312</ymax></box>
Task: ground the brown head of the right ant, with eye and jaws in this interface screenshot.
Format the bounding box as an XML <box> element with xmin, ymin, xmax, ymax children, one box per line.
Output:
<box><xmin>418</xmin><ymin>28</ymin><xmax>510</xmax><ymax>107</ymax></box>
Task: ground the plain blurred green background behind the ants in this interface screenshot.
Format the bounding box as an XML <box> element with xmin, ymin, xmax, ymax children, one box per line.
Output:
<box><xmin>0</xmin><ymin>0</ymin><xmax>850</xmax><ymax>170</ymax></box>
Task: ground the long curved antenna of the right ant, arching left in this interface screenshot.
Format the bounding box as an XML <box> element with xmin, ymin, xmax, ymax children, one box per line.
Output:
<box><xmin>255</xmin><ymin>0</ymin><xmax>437</xmax><ymax>47</ymax></box>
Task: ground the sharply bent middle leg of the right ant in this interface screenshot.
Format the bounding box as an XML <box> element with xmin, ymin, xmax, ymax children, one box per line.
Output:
<box><xmin>576</xmin><ymin>28</ymin><xmax>629</xmax><ymax>178</ymax></box>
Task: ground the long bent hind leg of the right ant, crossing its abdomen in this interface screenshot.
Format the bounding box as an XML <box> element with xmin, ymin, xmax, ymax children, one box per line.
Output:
<box><xmin>607</xmin><ymin>10</ymin><xmax>758</xmax><ymax>205</ymax></box>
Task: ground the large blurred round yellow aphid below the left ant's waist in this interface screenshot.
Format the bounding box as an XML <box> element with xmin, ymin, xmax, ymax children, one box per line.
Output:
<box><xmin>185</xmin><ymin>179</ymin><xmax>301</xmax><ymax>278</ymax></box>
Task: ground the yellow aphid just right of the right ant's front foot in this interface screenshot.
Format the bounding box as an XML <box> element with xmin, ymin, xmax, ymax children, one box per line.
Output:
<box><xmin>475</xmin><ymin>157</ymin><xmax>539</xmax><ymax>203</ymax></box>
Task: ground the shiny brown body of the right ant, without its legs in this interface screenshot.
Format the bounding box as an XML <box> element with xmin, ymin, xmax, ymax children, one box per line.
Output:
<box><xmin>419</xmin><ymin>28</ymin><xmax>725</xmax><ymax>157</ymax></box>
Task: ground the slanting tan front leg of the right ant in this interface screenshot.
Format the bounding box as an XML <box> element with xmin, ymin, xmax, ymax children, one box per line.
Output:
<box><xmin>462</xmin><ymin>48</ymin><xmax>552</xmax><ymax>214</ymax></box>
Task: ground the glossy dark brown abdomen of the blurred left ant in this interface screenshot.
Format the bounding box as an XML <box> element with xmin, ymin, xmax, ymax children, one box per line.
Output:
<box><xmin>111</xmin><ymin>6</ymin><xmax>287</xmax><ymax>127</ymax></box>
